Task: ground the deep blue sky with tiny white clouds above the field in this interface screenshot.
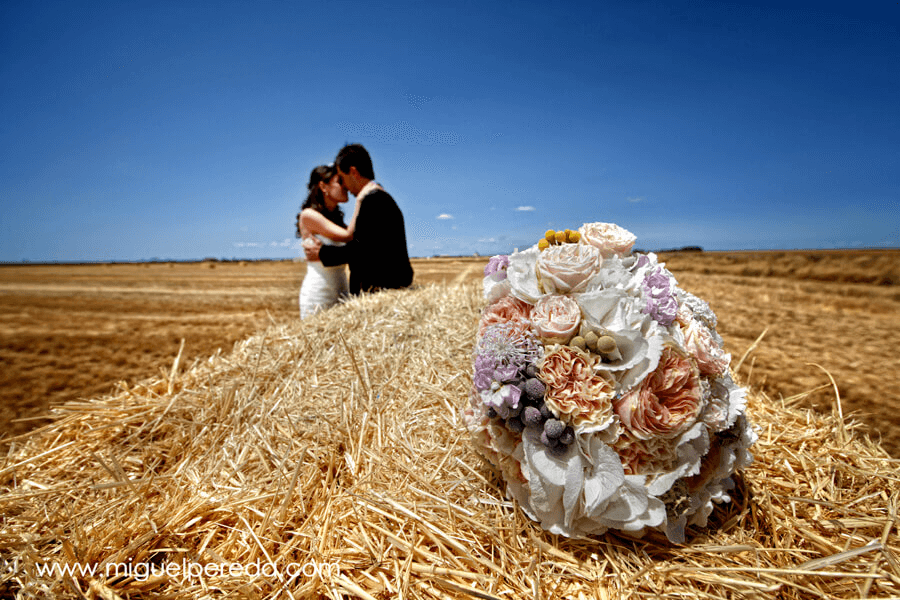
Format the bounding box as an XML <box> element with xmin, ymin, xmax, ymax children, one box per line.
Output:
<box><xmin>0</xmin><ymin>0</ymin><xmax>900</xmax><ymax>261</ymax></box>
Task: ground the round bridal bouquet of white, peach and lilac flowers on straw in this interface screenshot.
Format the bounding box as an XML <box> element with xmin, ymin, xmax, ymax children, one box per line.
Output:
<box><xmin>463</xmin><ymin>223</ymin><xmax>756</xmax><ymax>543</ymax></box>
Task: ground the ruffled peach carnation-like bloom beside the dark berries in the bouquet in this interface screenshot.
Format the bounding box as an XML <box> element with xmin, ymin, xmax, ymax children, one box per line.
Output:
<box><xmin>538</xmin><ymin>346</ymin><xmax>616</xmax><ymax>431</ymax></box>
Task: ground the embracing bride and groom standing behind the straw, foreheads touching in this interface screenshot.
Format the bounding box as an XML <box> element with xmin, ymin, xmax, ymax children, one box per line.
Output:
<box><xmin>298</xmin><ymin>144</ymin><xmax>413</xmax><ymax>318</ymax></box>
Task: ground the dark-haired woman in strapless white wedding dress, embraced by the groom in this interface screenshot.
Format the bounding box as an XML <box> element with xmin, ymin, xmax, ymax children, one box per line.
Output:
<box><xmin>298</xmin><ymin>164</ymin><xmax>360</xmax><ymax>319</ymax></box>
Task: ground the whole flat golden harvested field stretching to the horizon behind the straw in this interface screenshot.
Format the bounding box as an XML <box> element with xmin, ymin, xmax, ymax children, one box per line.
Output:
<box><xmin>0</xmin><ymin>250</ymin><xmax>900</xmax><ymax>456</ymax></box>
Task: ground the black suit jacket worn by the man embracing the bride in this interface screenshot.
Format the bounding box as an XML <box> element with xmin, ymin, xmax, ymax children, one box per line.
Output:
<box><xmin>319</xmin><ymin>189</ymin><xmax>413</xmax><ymax>294</ymax></box>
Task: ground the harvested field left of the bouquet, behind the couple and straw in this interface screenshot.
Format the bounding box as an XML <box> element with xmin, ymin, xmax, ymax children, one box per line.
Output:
<box><xmin>0</xmin><ymin>260</ymin><xmax>484</xmax><ymax>440</ymax></box>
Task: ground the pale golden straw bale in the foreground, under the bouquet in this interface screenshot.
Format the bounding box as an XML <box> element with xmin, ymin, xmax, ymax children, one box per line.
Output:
<box><xmin>0</xmin><ymin>285</ymin><xmax>900</xmax><ymax>599</ymax></box>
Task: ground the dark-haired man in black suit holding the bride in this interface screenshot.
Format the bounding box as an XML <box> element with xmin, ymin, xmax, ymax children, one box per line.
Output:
<box><xmin>304</xmin><ymin>144</ymin><xmax>413</xmax><ymax>294</ymax></box>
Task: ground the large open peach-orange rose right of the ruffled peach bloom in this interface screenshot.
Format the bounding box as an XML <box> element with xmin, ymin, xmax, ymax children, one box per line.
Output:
<box><xmin>615</xmin><ymin>346</ymin><xmax>703</xmax><ymax>440</ymax></box>
